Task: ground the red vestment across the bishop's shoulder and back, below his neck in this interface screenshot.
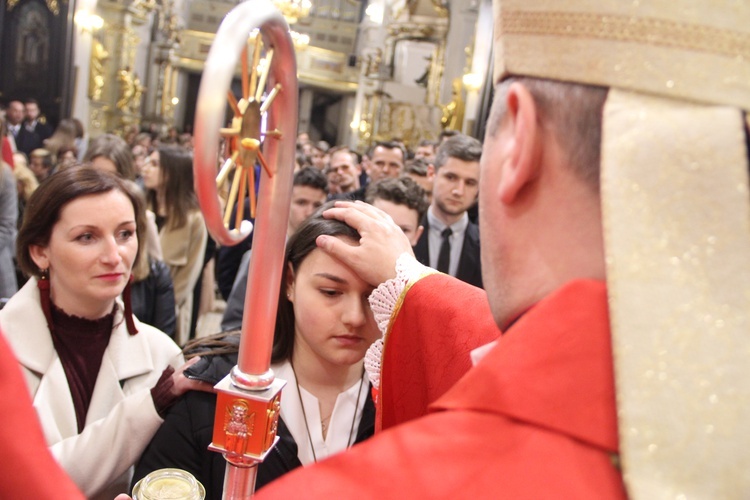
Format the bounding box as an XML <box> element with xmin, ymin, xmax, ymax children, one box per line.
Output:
<box><xmin>257</xmin><ymin>281</ymin><xmax>626</xmax><ymax>500</ymax></box>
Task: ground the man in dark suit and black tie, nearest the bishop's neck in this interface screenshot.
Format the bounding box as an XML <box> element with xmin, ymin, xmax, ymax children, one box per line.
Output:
<box><xmin>414</xmin><ymin>134</ymin><xmax>482</xmax><ymax>288</ymax></box>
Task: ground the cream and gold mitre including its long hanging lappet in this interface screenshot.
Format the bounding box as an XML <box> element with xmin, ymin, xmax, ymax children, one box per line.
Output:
<box><xmin>494</xmin><ymin>0</ymin><xmax>750</xmax><ymax>500</ymax></box>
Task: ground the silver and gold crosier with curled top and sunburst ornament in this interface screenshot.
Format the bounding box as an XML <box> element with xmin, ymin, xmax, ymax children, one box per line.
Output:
<box><xmin>194</xmin><ymin>0</ymin><xmax>298</xmax><ymax>499</ymax></box>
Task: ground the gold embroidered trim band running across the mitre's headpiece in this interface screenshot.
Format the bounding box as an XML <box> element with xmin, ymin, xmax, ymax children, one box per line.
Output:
<box><xmin>495</xmin><ymin>11</ymin><xmax>750</xmax><ymax>57</ymax></box>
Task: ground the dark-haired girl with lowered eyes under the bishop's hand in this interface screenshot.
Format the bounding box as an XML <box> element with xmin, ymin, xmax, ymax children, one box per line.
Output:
<box><xmin>134</xmin><ymin>205</ymin><xmax>379</xmax><ymax>498</ymax></box>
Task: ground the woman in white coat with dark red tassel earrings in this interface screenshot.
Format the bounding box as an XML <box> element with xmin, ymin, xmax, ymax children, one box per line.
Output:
<box><xmin>0</xmin><ymin>167</ymin><xmax>210</xmax><ymax>500</ymax></box>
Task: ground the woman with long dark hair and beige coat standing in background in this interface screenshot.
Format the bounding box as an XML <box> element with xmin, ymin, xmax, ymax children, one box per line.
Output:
<box><xmin>143</xmin><ymin>146</ymin><xmax>208</xmax><ymax>345</ymax></box>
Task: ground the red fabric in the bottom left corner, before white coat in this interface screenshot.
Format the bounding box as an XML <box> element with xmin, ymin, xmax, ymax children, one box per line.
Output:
<box><xmin>0</xmin><ymin>326</ymin><xmax>84</xmax><ymax>500</ymax></box>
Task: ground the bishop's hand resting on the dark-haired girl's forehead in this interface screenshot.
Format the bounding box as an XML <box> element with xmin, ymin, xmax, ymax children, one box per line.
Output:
<box><xmin>316</xmin><ymin>201</ymin><xmax>414</xmax><ymax>286</ymax></box>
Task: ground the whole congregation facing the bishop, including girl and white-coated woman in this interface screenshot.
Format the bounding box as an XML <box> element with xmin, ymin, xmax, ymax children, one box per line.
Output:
<box><xmin>0</xmin><ymin>84</ymin><xmax>481</xmax><ymax>498</ymax></box>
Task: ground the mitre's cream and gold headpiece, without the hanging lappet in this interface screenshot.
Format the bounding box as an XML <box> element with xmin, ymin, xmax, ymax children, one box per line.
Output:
<box><xmin>494</xmin><ymin>0</ymin><xmax>750</xmax><ymax>109</ymax></box>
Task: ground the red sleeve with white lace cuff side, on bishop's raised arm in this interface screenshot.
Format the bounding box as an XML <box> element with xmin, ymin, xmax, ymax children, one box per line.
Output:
<box><xmin>382</xmin><ymin>274</ymin><xmax>500</xmax><ymax>430</ymax></box>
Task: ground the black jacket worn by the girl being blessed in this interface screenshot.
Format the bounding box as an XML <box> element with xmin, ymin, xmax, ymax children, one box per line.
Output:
<box><xmin>133</xmin><ymin>336</ymin><xmax>375</xmax><ymax>500</ymax></box>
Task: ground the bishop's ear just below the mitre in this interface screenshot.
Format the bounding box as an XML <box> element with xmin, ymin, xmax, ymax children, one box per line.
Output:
<box><xmin>500</xmin><ymin>82</ymin><xmax>542</xmax><ymax>203</ymax></box>
